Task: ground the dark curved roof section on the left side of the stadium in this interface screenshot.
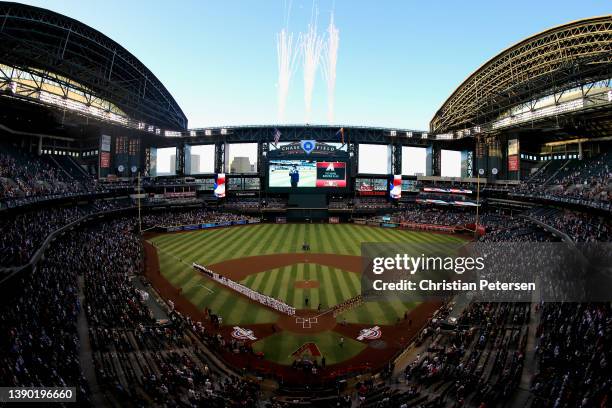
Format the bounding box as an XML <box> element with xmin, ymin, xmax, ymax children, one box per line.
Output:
<box><xmin>0</xmin><ymin>2</ymin><xmax>187</xmax><ymax>130</ymax></box>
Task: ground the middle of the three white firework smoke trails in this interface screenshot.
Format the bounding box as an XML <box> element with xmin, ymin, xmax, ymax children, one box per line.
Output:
<box><xmin>300</xmin><ymin>5</ymin><xmax>323</xmax><ymax>123</ymax></box>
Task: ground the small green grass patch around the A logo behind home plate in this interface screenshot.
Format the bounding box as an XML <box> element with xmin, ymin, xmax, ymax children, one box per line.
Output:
<box><xmin>253</xmin><ymin>331</ymin><xmax>367</xmax><ymax>365</ymax></box>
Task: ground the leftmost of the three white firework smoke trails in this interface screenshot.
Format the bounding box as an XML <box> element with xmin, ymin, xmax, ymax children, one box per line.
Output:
<box><xmin>276</xmin><ymin>28</ymin><xmax>298</xmax><ymax>123</ymax></box>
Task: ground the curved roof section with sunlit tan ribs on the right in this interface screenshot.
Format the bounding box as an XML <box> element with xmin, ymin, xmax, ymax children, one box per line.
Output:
<box><xmin>430</xmin><ymin>15</ymin><xmax>612</xmax><ymax>133</ymax></box>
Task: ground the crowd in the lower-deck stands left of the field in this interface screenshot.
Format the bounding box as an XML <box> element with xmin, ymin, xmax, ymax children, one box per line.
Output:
<box><xmin>0</xmin><ymin>218</ymin><xmax>266</xmax><ymax>408</ymax></box>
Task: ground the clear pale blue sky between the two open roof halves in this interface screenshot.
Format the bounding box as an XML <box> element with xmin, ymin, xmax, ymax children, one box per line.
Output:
<box><xmin>17</xmin><ymin>0</ymin><xmax>612</xmax><ymax>130</ymax></box>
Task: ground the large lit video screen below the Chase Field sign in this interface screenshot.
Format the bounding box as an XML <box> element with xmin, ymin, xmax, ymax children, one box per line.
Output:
<box><xmin>268</xmin><ymin>159</ymin><xmax>346</xmax><ymax>188</ymax></box>
